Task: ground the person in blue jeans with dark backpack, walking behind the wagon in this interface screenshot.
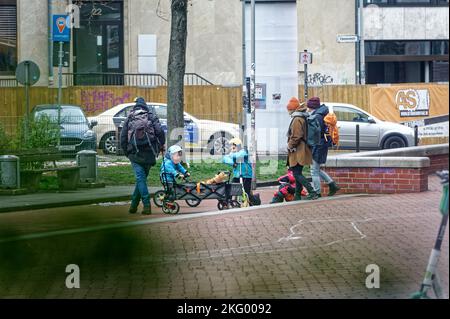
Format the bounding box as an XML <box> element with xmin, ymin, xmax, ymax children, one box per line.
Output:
<box><xmin>120</xmin><ymin>98</ymin><xmax>166</xmax><ymax>215</ymax></box>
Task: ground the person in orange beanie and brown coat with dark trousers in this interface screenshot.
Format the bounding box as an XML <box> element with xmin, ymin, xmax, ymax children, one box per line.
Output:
<box><xmin>287</xmin><ymin>97</ymin><xmax>318</xmax><ymax>201</ymax></box>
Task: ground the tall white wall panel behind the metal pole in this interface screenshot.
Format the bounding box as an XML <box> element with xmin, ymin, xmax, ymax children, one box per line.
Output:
<box><xmin>246</xmin><ymin>3</ymin><xmax>298</xmax><ymax>153</ymax></box>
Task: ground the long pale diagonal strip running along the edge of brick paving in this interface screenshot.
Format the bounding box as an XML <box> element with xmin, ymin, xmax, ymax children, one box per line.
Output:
<box><xmin>0</xmin><ymin>194</ymin><xmax>369</xmax><ymax>244</ymax></box>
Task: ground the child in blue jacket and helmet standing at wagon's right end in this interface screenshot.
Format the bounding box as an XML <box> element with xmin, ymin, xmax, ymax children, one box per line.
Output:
<box><xmin>222</xmin><ymin>138</ymin><xmax>259</xmax><ymax>205</ymax></box>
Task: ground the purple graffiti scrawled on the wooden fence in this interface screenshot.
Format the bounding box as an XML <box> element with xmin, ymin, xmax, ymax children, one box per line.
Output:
<box><xmin>81</xmin><ymin>90</ymin><xmax>132</xmax><ymax>114</ymax></box>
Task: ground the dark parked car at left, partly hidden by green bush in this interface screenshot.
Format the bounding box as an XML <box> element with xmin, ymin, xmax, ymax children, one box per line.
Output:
<box><xmin>31</xmin><ymin>105</ymin><xmax>97</xmax><ymax>155</ymax></box>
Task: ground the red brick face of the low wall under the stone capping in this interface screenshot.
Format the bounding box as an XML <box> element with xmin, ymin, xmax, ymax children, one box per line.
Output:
<box><xmin>322</xmin><ymin>168</ymin><xmax>428</xmax><ymax>194</ymax></box>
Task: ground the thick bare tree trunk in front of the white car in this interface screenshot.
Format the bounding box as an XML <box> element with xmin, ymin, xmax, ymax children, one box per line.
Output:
<box><xmin>167</xmin><ymin>0</ymin><xmax>188</xmax><ymax>147</ymax></box>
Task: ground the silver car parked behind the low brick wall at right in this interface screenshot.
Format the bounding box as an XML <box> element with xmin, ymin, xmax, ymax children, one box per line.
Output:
<box><xmin>324</xmin><ymin>102</ymin><xmax>414</xmax><ymax>150</ymax></box>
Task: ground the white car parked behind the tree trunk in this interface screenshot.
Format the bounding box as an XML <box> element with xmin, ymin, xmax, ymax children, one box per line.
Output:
<box><xmin>89</xmin><ymin>103</ymin><xmax>239</xmax><ymax>154</ymax></box>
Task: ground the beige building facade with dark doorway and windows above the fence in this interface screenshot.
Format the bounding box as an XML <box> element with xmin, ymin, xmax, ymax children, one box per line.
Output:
<box><xmin>0</xmin><ymin>0</ymin><xmax>449</xmax><ymax>87</ymax></box>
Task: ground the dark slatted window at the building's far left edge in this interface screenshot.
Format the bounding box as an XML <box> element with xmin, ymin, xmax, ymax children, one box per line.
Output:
<box><xmin>0</xmin><ymin>0</ymin><xmax>17</xmax><ymax>75</ymax></box>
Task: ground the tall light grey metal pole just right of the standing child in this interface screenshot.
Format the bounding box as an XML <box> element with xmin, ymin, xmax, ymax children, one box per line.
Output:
<box><xmin>250</xmin><ymin>0</ymin><xmax>257</xmax><ymax>189</ymax></box>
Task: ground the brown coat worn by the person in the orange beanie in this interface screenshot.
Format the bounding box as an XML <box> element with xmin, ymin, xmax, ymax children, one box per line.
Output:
<box><xmin>288</xmin><ymin>117</ymin><xmax>312</xmax><ymax>167</ymax></box>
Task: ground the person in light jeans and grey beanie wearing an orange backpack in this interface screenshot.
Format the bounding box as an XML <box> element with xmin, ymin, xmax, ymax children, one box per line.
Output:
<box><xmin>308</xmin><ymin>97</ymin><xmax>340</xmax><ymax>197</ymax></box>
